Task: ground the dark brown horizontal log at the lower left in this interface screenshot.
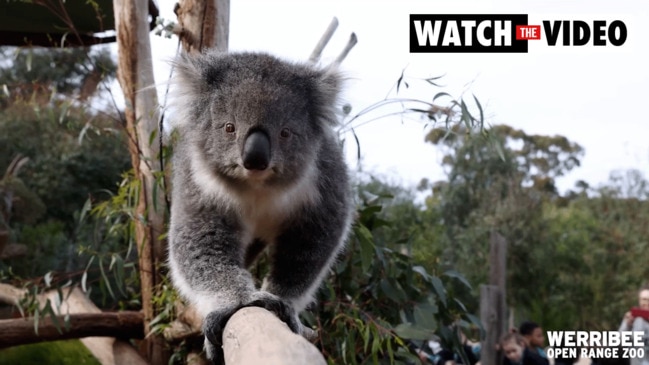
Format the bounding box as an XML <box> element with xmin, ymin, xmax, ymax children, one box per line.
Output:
<box><xmin>0</xmin><ymin>311</ymin><xmax>144</xmax><ymax>348</ymax></box>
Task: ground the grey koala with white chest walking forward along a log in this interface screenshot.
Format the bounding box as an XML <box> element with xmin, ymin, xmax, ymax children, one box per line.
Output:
<box><xmin>168</xmin><ymin>51</ymin><xmax>353</xmax><ymax>362</ymax></box>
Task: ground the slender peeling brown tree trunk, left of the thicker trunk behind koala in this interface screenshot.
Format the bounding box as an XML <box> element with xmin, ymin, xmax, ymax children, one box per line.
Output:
<box><xmin>113</xmin><ymin>0</ymin><xmax>170</xmax><ymax>364</ymax></box>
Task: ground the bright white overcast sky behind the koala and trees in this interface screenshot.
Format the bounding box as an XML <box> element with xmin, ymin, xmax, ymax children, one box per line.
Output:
<box><xmin>153</xmin><ymin>0</ymin><xmax>649</xmax><ymax>191</ymax></box>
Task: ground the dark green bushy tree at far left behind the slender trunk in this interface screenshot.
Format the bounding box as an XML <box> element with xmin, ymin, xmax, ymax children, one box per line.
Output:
<box><xmin>0</xmin><ymin>47</ymin><xmax>128</xmax><ymax>277</ymax></box>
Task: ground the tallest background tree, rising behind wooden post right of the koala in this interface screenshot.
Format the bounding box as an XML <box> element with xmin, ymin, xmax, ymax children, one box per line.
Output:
<box><xmin>426</xmin><ymin>125</ymin><xmax>582</xmax><ymax>304</ymax></box>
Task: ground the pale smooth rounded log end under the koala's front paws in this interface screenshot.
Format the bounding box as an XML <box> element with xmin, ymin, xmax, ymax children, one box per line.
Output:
<box><xmin>223</xmin><ymin>307</ymin><xmax>326</xmax><ymax>365</ymax></box>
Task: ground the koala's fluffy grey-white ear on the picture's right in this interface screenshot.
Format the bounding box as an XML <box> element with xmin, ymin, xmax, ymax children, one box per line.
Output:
<box><xmin>311</xmin><ymin>68</ymin><xmax>342</xmax><ymax>126</ymax></box>
